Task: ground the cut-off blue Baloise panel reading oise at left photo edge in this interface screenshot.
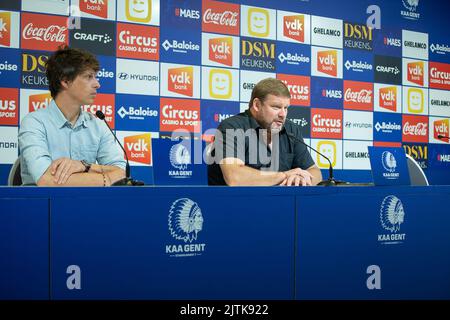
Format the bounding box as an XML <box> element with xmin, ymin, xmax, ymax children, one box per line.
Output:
<box><xmin>0</xmin><ymin>48</ymin><xmax>21</xmax><ymax>88</ymax></box>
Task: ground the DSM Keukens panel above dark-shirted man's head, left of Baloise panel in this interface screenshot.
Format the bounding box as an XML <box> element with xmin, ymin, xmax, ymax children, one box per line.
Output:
<box><xmin>241</xmin><ymin>38</ymin><xmax>275</xmax><ymax>72</ymax></box>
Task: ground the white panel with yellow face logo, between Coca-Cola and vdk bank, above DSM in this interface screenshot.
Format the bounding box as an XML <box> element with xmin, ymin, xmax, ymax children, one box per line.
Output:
<box><xmin>241</xmin><ymin>5</ymin><xmax>277</xmax><ymax>40</ymax></box>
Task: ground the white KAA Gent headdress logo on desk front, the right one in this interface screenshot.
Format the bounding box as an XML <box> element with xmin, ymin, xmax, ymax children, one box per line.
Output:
<box><xmin>378</xmin><ymin>195</ymin><xmax>406</xmax><ymax>244</ymax></box>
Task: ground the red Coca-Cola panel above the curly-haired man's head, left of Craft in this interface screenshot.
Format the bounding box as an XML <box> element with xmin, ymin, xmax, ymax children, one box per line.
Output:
<box><xmin>21</xmin><ymin>13</ymin><xmax>69</xmax><ymax>50</ymax></box>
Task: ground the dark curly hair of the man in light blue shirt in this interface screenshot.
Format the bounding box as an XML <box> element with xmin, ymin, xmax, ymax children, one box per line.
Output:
<box><xmin>45</xmin><ymin>46</ymin><xmax>100</xmax><ymax>99</ymax></box>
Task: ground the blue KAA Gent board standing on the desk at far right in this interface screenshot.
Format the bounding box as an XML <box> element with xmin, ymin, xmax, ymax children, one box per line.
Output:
<box><xmin>368</xmin><ymin>146</ymin><xmax>411</xmax><ymax>186</ymax></box>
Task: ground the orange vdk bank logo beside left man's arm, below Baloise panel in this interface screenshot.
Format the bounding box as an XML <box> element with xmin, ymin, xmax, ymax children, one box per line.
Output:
<box><xmin>123</xmin><ymin>133</ymin><xmax>152</xmax><ymax>165</ymax></box>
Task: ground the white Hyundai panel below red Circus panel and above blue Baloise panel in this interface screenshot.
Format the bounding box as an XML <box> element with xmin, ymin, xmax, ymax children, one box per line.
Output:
<box><xmin>116</xmin><ymin>59</ymin><xmax>159</xmax><ymax>96</ymax></box>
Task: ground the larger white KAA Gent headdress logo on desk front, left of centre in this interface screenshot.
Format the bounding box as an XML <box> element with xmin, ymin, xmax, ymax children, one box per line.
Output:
<box><xmin>166</xmin><ymin>198</ymin><xmax>206</xmax><ymax>257</ymax></box>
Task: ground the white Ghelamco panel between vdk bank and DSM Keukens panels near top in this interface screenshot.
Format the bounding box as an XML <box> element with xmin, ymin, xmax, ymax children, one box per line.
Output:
<box><xmin>311</xmin><ymin>16</ymin><xmax>343</xmax><ymax>49</ymax></box>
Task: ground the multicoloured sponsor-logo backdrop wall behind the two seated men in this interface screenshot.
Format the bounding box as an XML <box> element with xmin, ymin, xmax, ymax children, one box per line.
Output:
<box><xmin>0</xmin><ymin>0</ymin><xmax>450</xmax><ymax>184</ymax></box>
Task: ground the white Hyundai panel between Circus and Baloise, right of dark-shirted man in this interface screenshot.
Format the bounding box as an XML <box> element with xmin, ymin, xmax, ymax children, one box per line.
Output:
<box><xmin>344</xmin><ymin>110</ymin><xmax>373</xmax><ymax>140</ymax></box>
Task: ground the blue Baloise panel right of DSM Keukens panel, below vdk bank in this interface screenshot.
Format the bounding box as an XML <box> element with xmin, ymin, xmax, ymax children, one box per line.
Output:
<box><xmin>276</xmin><ymin>41</ymin><xmax>311</xmax><ymax>76</ymax></box>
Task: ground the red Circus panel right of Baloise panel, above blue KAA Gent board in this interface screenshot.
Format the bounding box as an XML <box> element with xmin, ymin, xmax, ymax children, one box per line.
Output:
<box><xmin>160</xmin><ymin>98</ymin><xmax>200</xmax><ymax>132</ymax></box>
